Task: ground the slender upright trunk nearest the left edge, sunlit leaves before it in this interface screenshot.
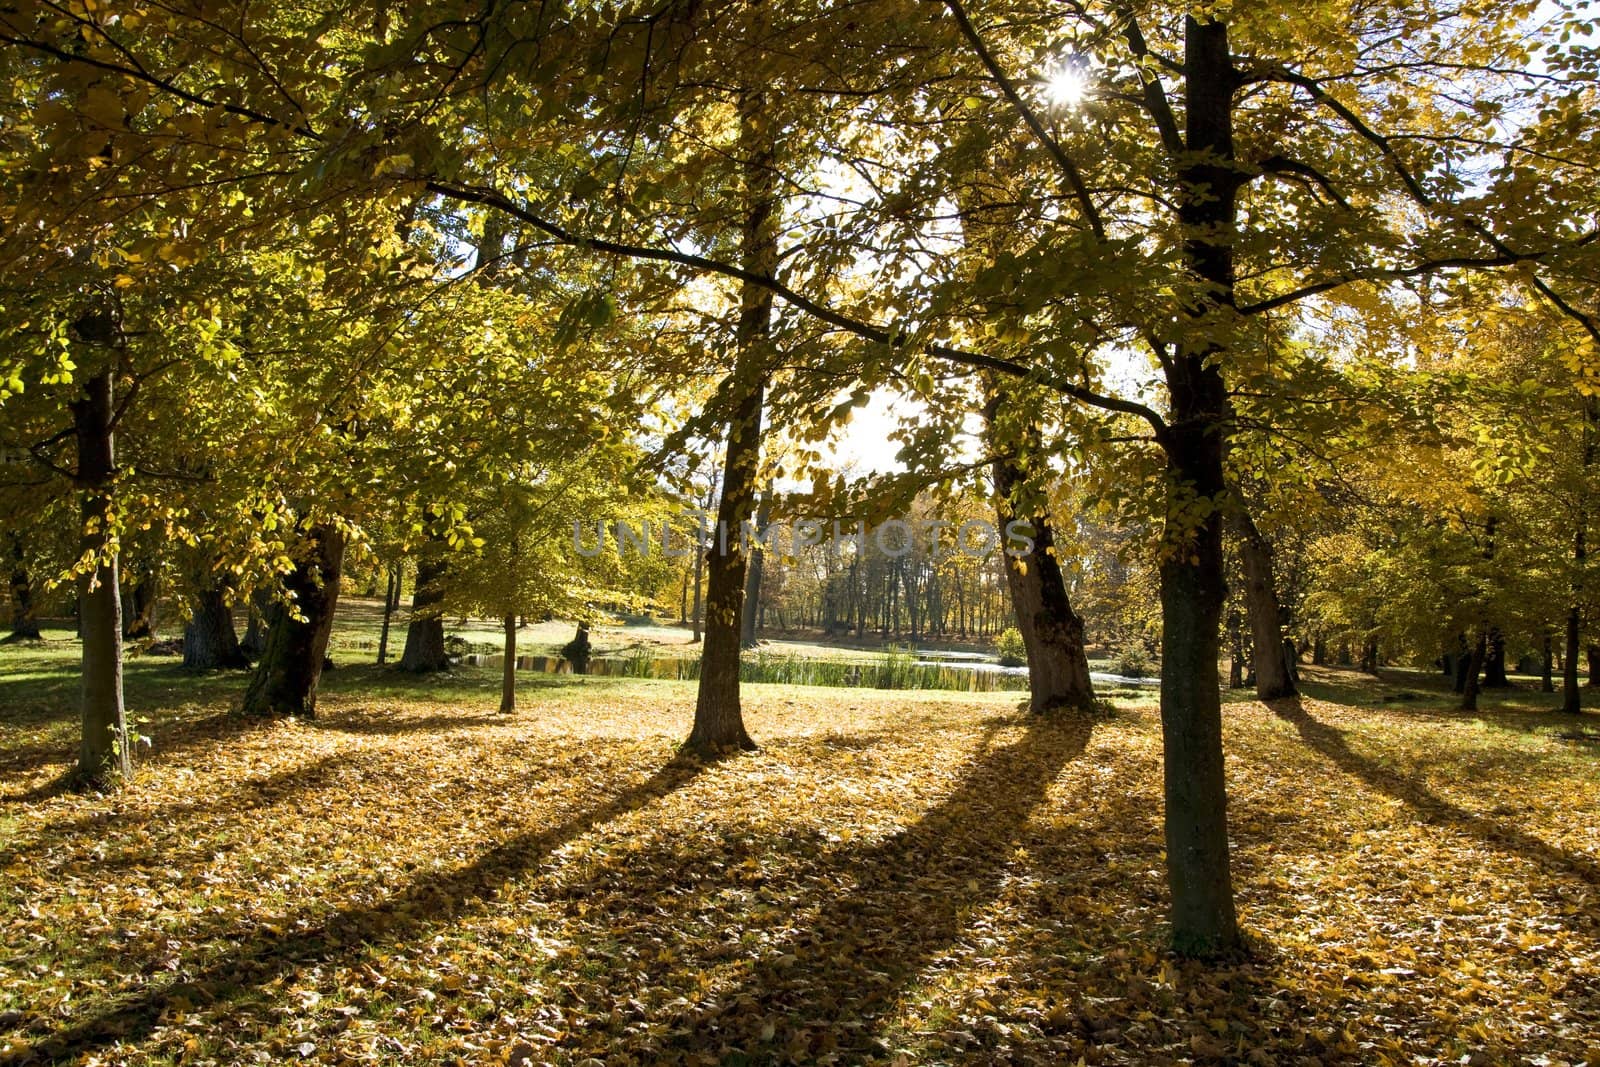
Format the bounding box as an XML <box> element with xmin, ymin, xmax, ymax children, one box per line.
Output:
<box><xmin>72</xmin><ymin>371</ymin><xmax>133</xmax><ymax>785</ymax></box>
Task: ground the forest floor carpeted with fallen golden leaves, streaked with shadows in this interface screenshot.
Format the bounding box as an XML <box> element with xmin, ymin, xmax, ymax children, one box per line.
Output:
<box><xmin>0</xmin><ymin>640</ymin><xmax>1600</xmax><ymax>1064</ymax></box>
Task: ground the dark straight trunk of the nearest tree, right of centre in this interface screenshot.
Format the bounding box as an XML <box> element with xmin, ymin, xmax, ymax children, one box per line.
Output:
<box><xmin>1160</xmin><ymin>16</ymin><xmax>1242</xmax><ymax>955</ymax></box>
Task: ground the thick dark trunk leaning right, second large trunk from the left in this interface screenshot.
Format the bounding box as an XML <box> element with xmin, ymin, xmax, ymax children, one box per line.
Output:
<box><xmin>245</xmin><ymin>525</ymin><xmax>344</xmax><ymax>718</ymax></box>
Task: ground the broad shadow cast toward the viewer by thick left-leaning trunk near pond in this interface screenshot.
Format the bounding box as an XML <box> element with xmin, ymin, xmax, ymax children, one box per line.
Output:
<box><xmin>646</xmin><ymin>720</ymin><xmax>1091</xmax><ymax>1059</ymax></box>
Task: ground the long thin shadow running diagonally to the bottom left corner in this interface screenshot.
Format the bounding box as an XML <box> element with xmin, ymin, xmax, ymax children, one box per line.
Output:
<box><xmin>0</xmin><ymin>758</ymin><xmax>706</xmax><ymax>1065</ymax></box>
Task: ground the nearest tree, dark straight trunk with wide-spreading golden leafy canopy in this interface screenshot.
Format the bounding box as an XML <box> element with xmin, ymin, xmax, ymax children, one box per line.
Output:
<box><xmin>12</xmin><ymin>0</ymin><xmax>1600</xmax><ymax>953</ymax></box>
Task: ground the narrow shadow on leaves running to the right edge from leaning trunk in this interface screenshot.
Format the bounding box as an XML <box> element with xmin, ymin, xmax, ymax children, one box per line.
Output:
<box><xmin>1267</xmin><ymin>696</ymin><xmax>1600</xmax><ymax>886</ymax></box>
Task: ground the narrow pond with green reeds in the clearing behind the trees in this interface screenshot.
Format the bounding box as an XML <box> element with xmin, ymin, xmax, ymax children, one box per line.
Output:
<box><xmin>466</xmin><ymin>649</ymin><xmax>1160</xmax><ymax>693</ymax></box>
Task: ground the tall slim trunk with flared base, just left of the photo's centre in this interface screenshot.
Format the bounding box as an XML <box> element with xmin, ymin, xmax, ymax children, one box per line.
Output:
<box><xmin>685</xmin><ymin>91</ymin><xmax>778</xmax><ymax>755</ymax></box>
